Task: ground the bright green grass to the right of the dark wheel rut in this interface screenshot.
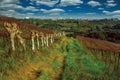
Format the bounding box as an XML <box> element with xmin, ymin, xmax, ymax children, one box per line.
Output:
<box><xmin>62</xmin><ymin>39</ymin><xmax>118</xmax><ymax>80</ymax></box>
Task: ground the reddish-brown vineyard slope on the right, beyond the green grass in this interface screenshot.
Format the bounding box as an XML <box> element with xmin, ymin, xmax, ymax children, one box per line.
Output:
<box><xmin>76</xmin><ymin>36</ymin><xmax>120</xmax><ymax>53</ymax></box>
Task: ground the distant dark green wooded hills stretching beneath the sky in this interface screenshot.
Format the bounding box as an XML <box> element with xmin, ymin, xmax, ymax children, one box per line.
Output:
<box><xmin>22</xmin><ymin>18</ymin><xmax>120</xmax><ymax>43</ymax></box>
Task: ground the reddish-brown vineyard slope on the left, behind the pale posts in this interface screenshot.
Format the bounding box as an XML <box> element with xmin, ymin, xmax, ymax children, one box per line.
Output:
<box><xmin>0</xmin><ymin>16</ymin><xmax>53</xmax><ymax>38</ymax></box>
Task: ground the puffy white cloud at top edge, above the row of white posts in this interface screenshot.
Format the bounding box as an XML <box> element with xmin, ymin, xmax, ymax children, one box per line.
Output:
<box><xmin>31</xmin><ymin>0</ymin><xmax>59</xmax><ymax>7</ymax></box>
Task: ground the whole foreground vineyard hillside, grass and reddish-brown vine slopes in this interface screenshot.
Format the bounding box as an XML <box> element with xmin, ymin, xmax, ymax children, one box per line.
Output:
<box><xmin>0</xmin><ymin>16</ymin><xmax>120</xmax><ymax>80</ymax></box>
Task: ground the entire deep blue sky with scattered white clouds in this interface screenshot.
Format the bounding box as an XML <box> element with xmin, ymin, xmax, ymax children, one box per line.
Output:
<box><xmin>0</xmin><ymin>0</ymin><xmax>120</xmax><ymax>19</ymax></box>
